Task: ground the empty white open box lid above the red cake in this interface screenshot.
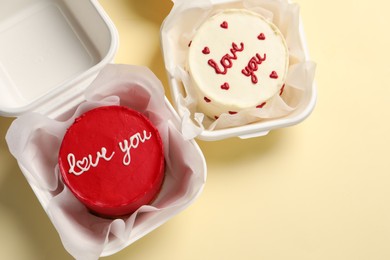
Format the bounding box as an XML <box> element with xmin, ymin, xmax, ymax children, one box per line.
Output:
<box><xmin>0</xmin><ymin>0</ymin><xmax>118</xmax><ymax>118</ymax></box>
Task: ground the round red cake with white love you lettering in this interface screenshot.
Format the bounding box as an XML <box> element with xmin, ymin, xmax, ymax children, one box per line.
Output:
<box><xmin>58</xmin><ymin>106</ymin><xmax>164</xmax><ymax>217</ymax></box>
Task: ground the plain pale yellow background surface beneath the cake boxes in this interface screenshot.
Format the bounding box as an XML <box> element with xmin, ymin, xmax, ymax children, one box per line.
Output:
<box><xmin>0</xmin><ymin>0</ymin><xmax>390</xmax><ymax>260</ymax></box>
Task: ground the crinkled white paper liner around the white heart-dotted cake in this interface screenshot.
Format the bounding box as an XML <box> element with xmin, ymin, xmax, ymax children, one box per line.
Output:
<box><xmin>161</xmin><ymin>0</ymin><xmax>315</xmax><ymax>138</ymax></box>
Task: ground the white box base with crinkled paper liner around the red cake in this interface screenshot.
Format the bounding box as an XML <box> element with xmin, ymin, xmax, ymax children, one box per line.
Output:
<box><xmin>6</xmin><ymin>65</ymin><xmax>206</xmax><ymax>259</ymax></box>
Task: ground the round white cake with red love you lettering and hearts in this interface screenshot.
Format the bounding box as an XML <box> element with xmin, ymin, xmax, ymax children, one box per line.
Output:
<box><xmin>187</xmin><ymin>9</ymin><xmax>289</xmax><ymax>118</ymax></box>
